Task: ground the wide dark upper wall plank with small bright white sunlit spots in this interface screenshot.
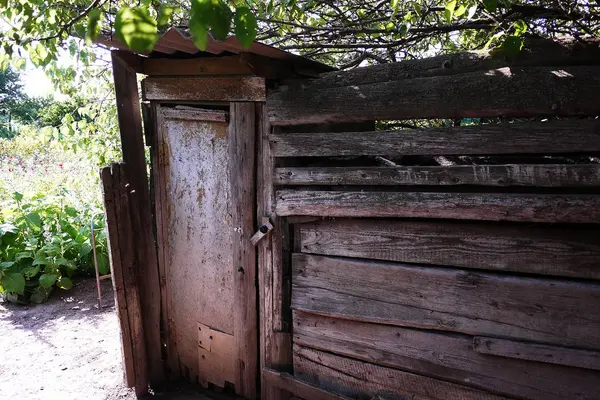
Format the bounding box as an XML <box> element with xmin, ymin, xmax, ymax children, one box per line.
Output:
<box><xmin>267</xmin><ymin>66</ymin><xmax>600</xmax><ymax>125</ymax></box>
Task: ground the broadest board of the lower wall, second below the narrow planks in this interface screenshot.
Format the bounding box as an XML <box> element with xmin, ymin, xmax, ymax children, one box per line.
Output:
<box><xmin>292</xmin><ymin>254</ymin><xmax>600</xmax><ymax>349</ymax></box>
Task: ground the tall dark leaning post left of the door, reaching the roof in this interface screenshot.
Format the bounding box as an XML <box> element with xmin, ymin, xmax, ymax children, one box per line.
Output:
<box><xmin>112</xmin><ymin>48</ymin><xmax>164</xmax><ymax>387</ymax></box>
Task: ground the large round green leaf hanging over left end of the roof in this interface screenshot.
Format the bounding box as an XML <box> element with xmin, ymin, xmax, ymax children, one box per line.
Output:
<box><xmin>115</xmin><ymin>7</ymin><xmax>158</xmax><ymax>52</ymax></box>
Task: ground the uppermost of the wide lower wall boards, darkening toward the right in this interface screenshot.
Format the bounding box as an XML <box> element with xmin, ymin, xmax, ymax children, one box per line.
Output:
<box><xmin>298</xmin><ymin>219</ymin><xmax>600</xmax><ymax>279</ymax></box>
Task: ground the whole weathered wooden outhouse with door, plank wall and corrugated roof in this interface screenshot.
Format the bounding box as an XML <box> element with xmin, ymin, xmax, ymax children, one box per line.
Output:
<box><xmin>102</xmin><ymin>29</ymin><xmax>600</xmax><ymax>400</ymax></box>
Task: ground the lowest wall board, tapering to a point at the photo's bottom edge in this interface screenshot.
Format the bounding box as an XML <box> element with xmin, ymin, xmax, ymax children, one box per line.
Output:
<box><xmin>294</xmin><ymin>345</ymin><xmax>505</xmax><ymax>400</ymax></box>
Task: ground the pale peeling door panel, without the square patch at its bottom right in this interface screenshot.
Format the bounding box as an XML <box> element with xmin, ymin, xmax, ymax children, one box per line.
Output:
<box><xmin>160</xmin><ymin>111</ymin><xmax>234</xmax><ymax>378</ymax></box>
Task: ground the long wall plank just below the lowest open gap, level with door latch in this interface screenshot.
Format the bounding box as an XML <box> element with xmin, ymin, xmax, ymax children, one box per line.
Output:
<box><xmin>275</xmin><ymin>190</ymin><xmax>600</xmax><ymax>223</ymax></box>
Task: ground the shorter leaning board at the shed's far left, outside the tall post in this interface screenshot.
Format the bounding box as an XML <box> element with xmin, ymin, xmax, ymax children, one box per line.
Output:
<box><xmin>102</xmin><ymin>164</ymin><xmax>149</xmax><ymax>397</ymax></box>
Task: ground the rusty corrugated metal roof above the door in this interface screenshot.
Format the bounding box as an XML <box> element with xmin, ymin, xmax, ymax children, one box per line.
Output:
<box><xmin>96</xmin><ymin>28</ymin><xmax>336</xmax><ymax>72</ymax></box>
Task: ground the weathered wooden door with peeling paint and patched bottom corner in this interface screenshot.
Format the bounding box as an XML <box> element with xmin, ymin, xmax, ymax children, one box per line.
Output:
<box><xmin>153</xmin><ymin>103</ymin><xmax>257</xmax><ymax>398</ymax></box>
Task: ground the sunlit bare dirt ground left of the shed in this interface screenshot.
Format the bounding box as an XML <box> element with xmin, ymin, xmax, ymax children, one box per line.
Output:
<box><xmin>0</xmin><ymin>279</ymin><xmax>135</xmax><ymax>400</ymax></box>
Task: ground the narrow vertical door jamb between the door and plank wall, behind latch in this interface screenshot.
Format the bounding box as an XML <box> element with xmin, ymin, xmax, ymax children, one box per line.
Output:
<box><xmin>256</xmin><ymin>103</ymin><xmax>292</xmax><ymax>400</ymax></box>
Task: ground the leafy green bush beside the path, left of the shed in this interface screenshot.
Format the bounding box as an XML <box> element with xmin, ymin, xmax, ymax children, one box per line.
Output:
<box><xmin>0</xmin><ymin>192</ymin><xmax>109</xmax><ymax>303</ymax></box>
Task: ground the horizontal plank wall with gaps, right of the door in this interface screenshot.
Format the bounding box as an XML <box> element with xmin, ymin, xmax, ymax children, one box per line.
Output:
<box><xmin>259</xmin><ymin>39</ymin><xmax>600</xmax><ymax>399</ymax></box>
